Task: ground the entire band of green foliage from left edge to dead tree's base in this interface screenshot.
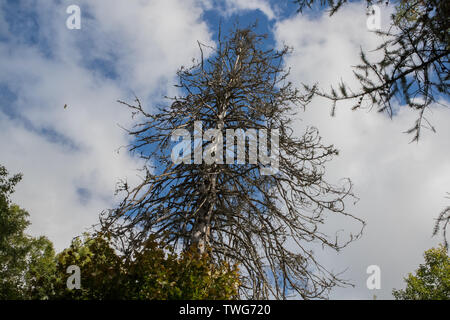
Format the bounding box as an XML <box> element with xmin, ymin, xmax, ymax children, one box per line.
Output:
<box><xmin>0</xmin><ymin>166</ymin><xmax>239</xmax><ymax>300</ymax></box>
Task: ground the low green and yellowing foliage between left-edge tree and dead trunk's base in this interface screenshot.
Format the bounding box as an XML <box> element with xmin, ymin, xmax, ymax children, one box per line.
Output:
<box><xmin>48</xmin><ymin>235</ymin><xmax>239</xmax><ymax>300</ymax></box>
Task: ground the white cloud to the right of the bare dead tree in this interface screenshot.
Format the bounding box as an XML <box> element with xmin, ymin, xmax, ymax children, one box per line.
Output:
<box><xmin>275</xmin><ymin>4</ymin><xmax>450</xmax><ymax>299</ymax></box>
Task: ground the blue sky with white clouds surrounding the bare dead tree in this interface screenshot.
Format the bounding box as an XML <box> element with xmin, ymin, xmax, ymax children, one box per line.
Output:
<box><xmin>0</xmin><ymin>0</ymin><xmax>450</xmax><ymax>299</ymax></box>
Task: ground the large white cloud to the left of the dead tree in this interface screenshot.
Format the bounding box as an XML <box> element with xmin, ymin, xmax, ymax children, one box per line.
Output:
<box><xmin>0</xmin><ymin>0</ymin><xmax>210</xmax><ymax>249</ymax></box>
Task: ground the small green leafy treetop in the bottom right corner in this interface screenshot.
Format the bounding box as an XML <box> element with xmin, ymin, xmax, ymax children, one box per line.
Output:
<box><xmin>392</xmin><ymin>245</ymin><xmax>450</xmax><ymax>300</ymax></box>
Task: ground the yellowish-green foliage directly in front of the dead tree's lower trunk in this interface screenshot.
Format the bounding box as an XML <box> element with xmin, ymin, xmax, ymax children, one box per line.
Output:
<box><xmin>128</xmin><ymin>240</ymin><xmax>239</xmax><ymax>300</ymax></box>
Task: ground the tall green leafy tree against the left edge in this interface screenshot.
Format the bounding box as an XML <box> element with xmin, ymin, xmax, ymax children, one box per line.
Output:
<box><xmin>0</xmin><ymin>165</ymin><xmax>56</xmax><ymax>300</ymax></box>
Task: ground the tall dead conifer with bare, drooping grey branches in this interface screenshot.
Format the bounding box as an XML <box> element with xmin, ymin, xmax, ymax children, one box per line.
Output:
<box><xmin>102</xmin><ymin>27</ymin><xmax>363</xmax><ymax>299</ymax></box>
